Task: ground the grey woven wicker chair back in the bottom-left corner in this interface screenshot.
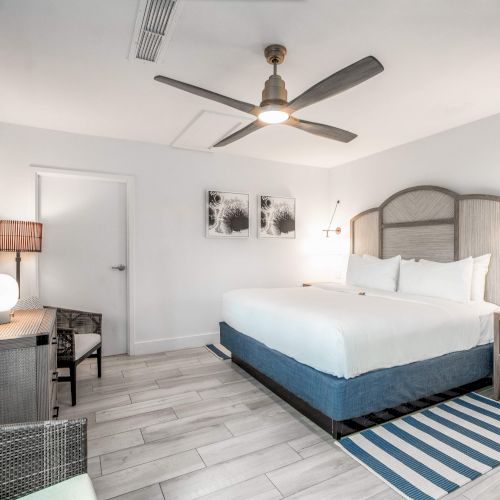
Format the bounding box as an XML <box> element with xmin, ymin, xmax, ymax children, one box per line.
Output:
<box><xmin>0</xmin><ymin>418</ymin><xmax>87</xmax><ymax>500</ymax></box>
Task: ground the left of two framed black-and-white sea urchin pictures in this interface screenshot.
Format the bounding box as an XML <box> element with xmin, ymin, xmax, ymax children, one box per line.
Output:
<box><xmin>207</xmin><ymin>191</ymin><xmax>249</xmax><ymax>238</ymax></box>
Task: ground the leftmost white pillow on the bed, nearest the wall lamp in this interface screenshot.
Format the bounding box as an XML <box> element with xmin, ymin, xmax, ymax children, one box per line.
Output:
<box><xmin>346</xmin><ymin>254</ymin><xmax>401</xmax><ymax>292</ymax></box>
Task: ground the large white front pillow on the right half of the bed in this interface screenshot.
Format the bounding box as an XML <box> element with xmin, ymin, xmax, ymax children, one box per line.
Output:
<box><xmin>398</xmin><ymin>257</ymin><xmax>473</xmax><ymax>302</ymax></box>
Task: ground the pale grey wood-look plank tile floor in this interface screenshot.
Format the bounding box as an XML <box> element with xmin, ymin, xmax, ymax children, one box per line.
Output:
<box><xmin>59</xmin><ymin>348</ymin><xmax>500</xmax><ymax>500</ymax></box>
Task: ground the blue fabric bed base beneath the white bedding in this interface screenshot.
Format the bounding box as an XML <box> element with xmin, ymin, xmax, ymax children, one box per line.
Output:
<box><xmin>220</xmin><ymin>322</ymin><xmax>493</xmax><ymax>436</ymax></box>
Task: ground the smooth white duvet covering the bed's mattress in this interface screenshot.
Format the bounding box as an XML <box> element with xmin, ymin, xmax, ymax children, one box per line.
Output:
<box><xmin>222</xmin><ymin>285</ymin><xmax>496</xmax><ymax>378</ymax></box>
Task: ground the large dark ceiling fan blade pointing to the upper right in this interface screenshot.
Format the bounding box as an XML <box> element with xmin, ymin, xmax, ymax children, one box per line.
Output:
<box><xmin>289</xmin><ymin>56</ymin><xmax>384</xmax><ymax>111</ymax></box>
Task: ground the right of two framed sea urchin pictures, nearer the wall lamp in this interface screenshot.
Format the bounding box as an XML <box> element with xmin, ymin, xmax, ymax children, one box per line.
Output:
<box><xmin>258</xmin><ymin>196</ymin><xmax>295</xmax><ymax>238</ymax></box>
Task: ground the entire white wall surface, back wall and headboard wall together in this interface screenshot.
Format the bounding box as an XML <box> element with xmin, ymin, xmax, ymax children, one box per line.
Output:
<box><xmin>7</xmin><ymin>111</ymin><xmax>500</xmax><ymax>352</ymax></box>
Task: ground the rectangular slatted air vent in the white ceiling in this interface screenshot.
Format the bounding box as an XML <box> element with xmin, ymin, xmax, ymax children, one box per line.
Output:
<box><xmin>129</xmin><ymin>0</ymin><xmax>181</xmax><ymax>62</ymax></box>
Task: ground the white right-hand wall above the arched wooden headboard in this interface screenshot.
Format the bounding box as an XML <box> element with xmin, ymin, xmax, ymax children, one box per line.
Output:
<box><xmin>330</xmin><ymin>111</ymin><xmax>500</xmax><ymax>278</ymax></box>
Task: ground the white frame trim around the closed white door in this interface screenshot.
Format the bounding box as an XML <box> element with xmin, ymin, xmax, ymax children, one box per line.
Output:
<box><xmin>30</xmin><ymin>165</ymin><xmax>135</xmax><ymax>355</ymax></box>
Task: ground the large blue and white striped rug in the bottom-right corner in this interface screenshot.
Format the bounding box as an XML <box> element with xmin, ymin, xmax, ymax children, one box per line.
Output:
<box><xmin>337</xmin><ymin>392</ymin><xmax>500</xmax><ymax>500</ymax></box>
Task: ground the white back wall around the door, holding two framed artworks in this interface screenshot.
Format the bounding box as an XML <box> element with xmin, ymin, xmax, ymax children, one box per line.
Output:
<box><xmin>0</xmin><ymin>124</ymin><xmax>330</xmax><ymax>352</ymax></box>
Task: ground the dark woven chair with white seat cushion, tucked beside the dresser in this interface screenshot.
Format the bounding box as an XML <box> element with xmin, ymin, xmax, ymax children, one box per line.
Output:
<box><xmin>57</xmin><ymin>308</ymin><xmax>102</xmax><ymax>406</ymax></box>
